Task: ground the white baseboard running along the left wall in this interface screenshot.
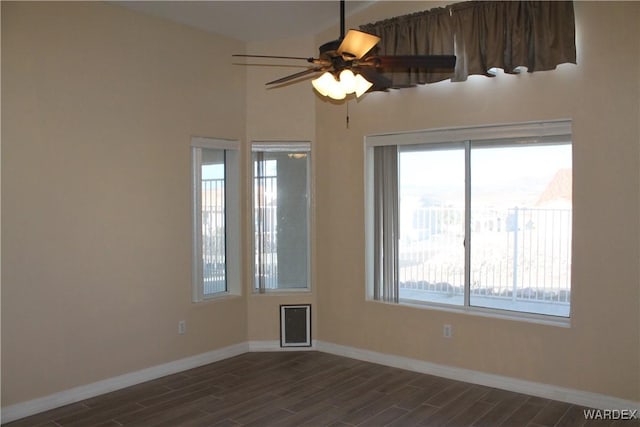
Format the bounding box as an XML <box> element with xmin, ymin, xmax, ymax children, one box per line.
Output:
<box><xmin>1</xmin><ymin>342</ymin><xmax>249</xmax><ymax>424</ymax></box>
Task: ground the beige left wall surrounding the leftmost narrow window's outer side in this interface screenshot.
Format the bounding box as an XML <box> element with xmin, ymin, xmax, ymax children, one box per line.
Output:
<box><xmin>2</xmin><ymin>2</ymin><xmax>247</xmax><ymax>406</ymax></box>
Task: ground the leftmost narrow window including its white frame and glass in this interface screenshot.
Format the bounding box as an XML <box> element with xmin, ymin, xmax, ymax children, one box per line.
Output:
<box><xmin>191</xmin><ymin>137</ymin><xmax>241</xmax><ymax>301</ymax></box>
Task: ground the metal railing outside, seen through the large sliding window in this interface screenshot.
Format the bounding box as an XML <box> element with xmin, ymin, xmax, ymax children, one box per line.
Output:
<box><xmin>399</xmin><ymin>207</ymin><xmax>571</xmax><ymax>310</ymax></box>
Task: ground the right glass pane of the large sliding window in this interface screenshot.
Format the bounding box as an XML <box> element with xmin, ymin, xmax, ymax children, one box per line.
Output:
<box><xmin>470</xmin><ymin>144</ymin><xmax>572</xmax><ymax>316</ymax></box>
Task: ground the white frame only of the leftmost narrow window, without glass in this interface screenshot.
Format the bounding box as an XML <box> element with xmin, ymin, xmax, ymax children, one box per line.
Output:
<box><xmin>190</xmin><ymin>137</ymin><xmax>242</xmax><ymax>303</ymax></box>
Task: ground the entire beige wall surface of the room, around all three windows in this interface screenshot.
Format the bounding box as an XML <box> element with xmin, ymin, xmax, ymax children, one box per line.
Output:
<box><xmin>2</xmin><ymin>2</ymin><xmax>640</xmax><ymax>412</ymax></box>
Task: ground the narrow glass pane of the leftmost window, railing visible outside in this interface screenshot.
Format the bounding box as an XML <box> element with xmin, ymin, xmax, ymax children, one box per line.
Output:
<box><xmin>200</xmin><ymin>149</ymin><xmax>227</xmax><ymax>296</ymax></box>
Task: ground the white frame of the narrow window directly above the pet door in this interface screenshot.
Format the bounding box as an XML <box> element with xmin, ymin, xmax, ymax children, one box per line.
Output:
<box><xmin>249</xmin><ymin>140</ymin><xmax>313</xmax><ymax>294</ymax></box>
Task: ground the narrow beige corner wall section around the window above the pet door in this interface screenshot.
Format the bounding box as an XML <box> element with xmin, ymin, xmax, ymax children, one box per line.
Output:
<box><xmin>245</xmin><ymin>37</ymin><xmax>317</xmax><ymax>343</ymax></box>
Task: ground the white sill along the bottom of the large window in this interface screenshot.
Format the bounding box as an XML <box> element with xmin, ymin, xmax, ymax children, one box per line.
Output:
<box><xmin>368</xmin><ymin>299</ymin><xmax>571</xmax><ymax>328</ymax></box>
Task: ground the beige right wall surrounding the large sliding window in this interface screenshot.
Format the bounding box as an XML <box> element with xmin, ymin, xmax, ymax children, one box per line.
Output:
<box><xmin>316</xmin><ymin>2</ymin><xmax>640</xmax><ymax>401</ymax></box>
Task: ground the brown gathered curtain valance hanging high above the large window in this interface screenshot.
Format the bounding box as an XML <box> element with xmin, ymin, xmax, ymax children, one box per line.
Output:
<box><xmin>360</xmin><ymin>1</ymin><xmax>576</xmax><ymax>87</ymax></box>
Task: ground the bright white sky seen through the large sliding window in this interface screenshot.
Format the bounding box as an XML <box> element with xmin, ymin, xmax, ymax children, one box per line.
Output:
<box><xmin>399</xmin><ymin>145</ymin><xmax>571</xmax><ymax>207</ymax></box>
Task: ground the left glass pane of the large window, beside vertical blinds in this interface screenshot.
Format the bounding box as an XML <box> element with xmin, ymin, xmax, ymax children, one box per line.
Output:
<box><xmin>398</xmin><ymin>148</ymin><xmax>465</xmax><ymax>305</ymax></box>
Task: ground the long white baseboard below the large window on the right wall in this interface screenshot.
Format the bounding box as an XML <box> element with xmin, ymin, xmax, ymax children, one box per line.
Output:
<box><xmin>316</xmin><ymin>341</ymin><xmax>640</xmax><ymax>410</ymax></box>
